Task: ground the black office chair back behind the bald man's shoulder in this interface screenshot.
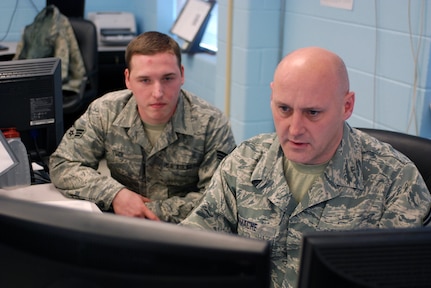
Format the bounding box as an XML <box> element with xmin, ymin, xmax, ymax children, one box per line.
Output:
<box><xmin>357</xmin><ymin>128</ymin><xmax>431</xmax><ymax>226</ymax></box>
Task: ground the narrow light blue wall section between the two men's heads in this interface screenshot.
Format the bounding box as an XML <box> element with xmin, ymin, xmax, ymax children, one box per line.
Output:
<box><xmin>216</xmin><ymin>0</ymin><xmax>281</xmax><ymax>142</ymax></box>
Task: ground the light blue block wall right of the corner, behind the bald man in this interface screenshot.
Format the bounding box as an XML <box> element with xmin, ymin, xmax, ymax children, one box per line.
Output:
<box><xmin>283</xmin><ymin>0</ymin><xmax>431</xmax><ymax>137</ymax></box>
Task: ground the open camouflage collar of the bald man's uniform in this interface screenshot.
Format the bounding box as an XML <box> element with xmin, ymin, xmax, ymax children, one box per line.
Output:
<box><xmin>251</xmin><ymin>123</ymin><xmax>363</xmax><ymax>210</ymax></box>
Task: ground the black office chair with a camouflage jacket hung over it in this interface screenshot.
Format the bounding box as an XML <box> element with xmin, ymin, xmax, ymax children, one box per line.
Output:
<box><xmin>63</xmin><ymin>18</ymin><xmax>99</xmax><ymax>115</ymax></box>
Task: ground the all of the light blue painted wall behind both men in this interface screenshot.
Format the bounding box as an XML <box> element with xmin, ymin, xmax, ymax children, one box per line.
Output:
<box><xmin>0</xmin><ymin>0</ymin><xmax>431</xmax><ymax>142</ymax></box>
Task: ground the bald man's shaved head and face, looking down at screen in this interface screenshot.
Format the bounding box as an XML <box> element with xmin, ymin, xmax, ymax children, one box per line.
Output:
<box><xmin>271</xmin><ymin>47</ymin><xmax>355</xmax><ymax>164</ymax></box>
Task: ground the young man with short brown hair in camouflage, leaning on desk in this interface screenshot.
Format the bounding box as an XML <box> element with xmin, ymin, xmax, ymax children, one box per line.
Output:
<box><xmin>49</xmin><ymin>31</ymin><xmax>236</xmax><ymax>223</ymax></box>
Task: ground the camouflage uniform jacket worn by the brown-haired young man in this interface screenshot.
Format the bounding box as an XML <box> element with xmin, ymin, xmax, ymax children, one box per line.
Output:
<box><xmin>50</xmin><ymin>90</ymin><xmax>235</xmax><ymax>222</ymax></box>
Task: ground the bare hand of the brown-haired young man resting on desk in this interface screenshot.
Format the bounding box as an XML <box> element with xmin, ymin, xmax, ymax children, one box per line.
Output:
<box><xmin>112</xmin><ymin>188</ymin><xmax>159</xmax><ymax>221</ymax></box>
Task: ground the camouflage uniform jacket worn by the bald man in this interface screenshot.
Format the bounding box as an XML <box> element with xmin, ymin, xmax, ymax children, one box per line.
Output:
<box><xmin>181</xmin><ymin>124</ymin><xmax>431</xmax><ymax>287</ymax></box>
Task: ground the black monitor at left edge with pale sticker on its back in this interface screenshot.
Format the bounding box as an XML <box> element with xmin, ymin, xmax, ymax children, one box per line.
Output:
<box><xmin>0</xmin><ymin>58</ymin><xmax>63</xmax><ymax>161</ymax></box>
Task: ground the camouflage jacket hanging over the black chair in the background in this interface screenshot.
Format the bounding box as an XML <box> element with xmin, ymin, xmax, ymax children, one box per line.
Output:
<box><xmin>13</xmin><ymin>6</ymin><xmax>86</xmax><ymax>93</ymax></box>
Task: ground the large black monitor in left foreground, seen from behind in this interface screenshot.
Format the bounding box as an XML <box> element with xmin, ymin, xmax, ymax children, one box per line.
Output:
<box><xmin>0</xmin><ymin>196</ymin><xmax>270</xmax><ymax>288</ymax></box>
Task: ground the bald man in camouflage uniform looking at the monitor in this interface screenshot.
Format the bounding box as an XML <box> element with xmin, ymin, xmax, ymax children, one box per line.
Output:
<box><xmin>180</xmin><ymin>47</ymin><xmax>431</xmax><ymax>287</ymax></box>
